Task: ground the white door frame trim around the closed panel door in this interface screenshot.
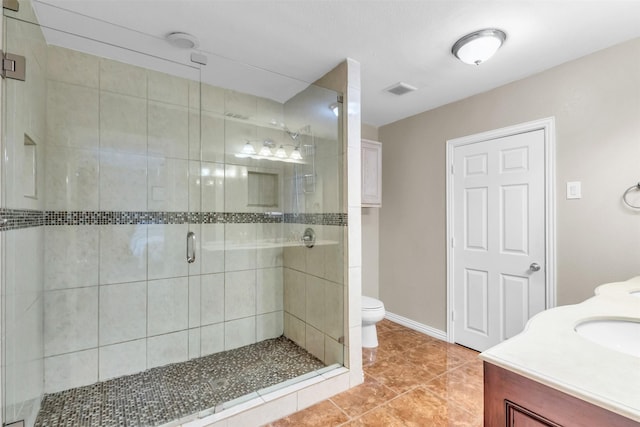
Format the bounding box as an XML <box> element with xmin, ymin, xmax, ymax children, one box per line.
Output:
<box><xmin>445</xmin><ymin>117</ymin><xmax>556</xmax><ymax>343</ymax></box>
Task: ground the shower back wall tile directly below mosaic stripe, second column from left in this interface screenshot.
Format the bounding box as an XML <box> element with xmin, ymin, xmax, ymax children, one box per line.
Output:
<box><xmin>99</xmin><ymin>224</ymin><xmax>147</xmax><ymax>285</ymax></box>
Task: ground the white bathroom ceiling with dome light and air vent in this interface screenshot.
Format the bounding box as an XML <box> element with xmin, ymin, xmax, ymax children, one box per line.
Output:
<box><xmin>35</xmin><ymin>0</ymin><xmax>640</xmax><ymax>126</ymax></box>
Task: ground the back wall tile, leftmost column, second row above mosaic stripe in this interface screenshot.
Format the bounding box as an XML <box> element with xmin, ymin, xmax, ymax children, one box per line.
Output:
<box><xmin>47</xmin><ymin>81</ymin><xmax>99</xmax><ymax>149</ymax></box>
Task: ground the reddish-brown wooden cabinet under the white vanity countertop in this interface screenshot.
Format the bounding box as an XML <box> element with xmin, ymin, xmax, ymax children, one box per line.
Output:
<box><xmin>484</xmin><ymin>362</ymin><xmax>640</xmax><ymax>427</ymax></box>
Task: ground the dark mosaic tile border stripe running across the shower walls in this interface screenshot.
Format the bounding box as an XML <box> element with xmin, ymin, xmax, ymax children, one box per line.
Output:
<box><xmin>0</xmin><ymin>209</ymin><xmax>348</xmax><ymax>231</ymax></box>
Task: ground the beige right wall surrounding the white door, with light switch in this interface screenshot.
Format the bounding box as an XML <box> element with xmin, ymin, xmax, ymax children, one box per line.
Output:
<box><xmin>379</xmin><ymin>39</ymin><xmax>640</xmax><ymax>330</ymax></box>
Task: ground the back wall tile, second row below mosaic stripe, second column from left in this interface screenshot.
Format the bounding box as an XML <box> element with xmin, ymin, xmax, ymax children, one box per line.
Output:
<box><xmin>99</xmin><ymin>282</ymin><xmax>147</xmax><ymax>346</ymax></box>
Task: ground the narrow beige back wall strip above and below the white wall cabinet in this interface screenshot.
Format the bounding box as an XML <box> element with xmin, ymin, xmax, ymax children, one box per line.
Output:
<box><xmin>362</xmin><ymin>123</ymin><xmax>380</xmax><ymax>298</ymax></box>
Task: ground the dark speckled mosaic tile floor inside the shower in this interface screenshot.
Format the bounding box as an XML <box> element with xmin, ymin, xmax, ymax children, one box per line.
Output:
<box><xmin>35</xmin><ymin>337</ymin><xmax>324</xmax><ymax>427</ymax></box>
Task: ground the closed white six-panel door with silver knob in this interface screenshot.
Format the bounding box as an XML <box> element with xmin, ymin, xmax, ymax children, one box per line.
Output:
<box><xmin>452</xmin><ymin>130</ymin><xmax>546</xmax><ymax>351</ymax></box>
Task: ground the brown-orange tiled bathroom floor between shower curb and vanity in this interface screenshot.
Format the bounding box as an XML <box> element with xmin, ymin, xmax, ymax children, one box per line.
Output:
<box><xmin>268</xmin><ymin>320</ymin><xmax>483</xmax><ymax>427</ymax></box>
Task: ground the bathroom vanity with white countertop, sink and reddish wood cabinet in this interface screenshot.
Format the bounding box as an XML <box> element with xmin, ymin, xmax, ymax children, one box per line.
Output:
<box><xmin>480</xmin><ymin>276</ymin><xmax>640</xmax><ymax>427</ymax></box>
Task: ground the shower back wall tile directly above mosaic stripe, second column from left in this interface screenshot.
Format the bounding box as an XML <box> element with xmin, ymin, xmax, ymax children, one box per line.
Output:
<box><xmin>100</xmin><ymin>151</ymin><xmax>147</xmax><ymax>212</ymax></box>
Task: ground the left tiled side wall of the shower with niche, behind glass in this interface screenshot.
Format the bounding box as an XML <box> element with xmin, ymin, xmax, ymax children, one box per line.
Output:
<box><xmin>0</xmin><ymin>5</ymin><xmax>46</xmax><ymax>425</ymax></box>
